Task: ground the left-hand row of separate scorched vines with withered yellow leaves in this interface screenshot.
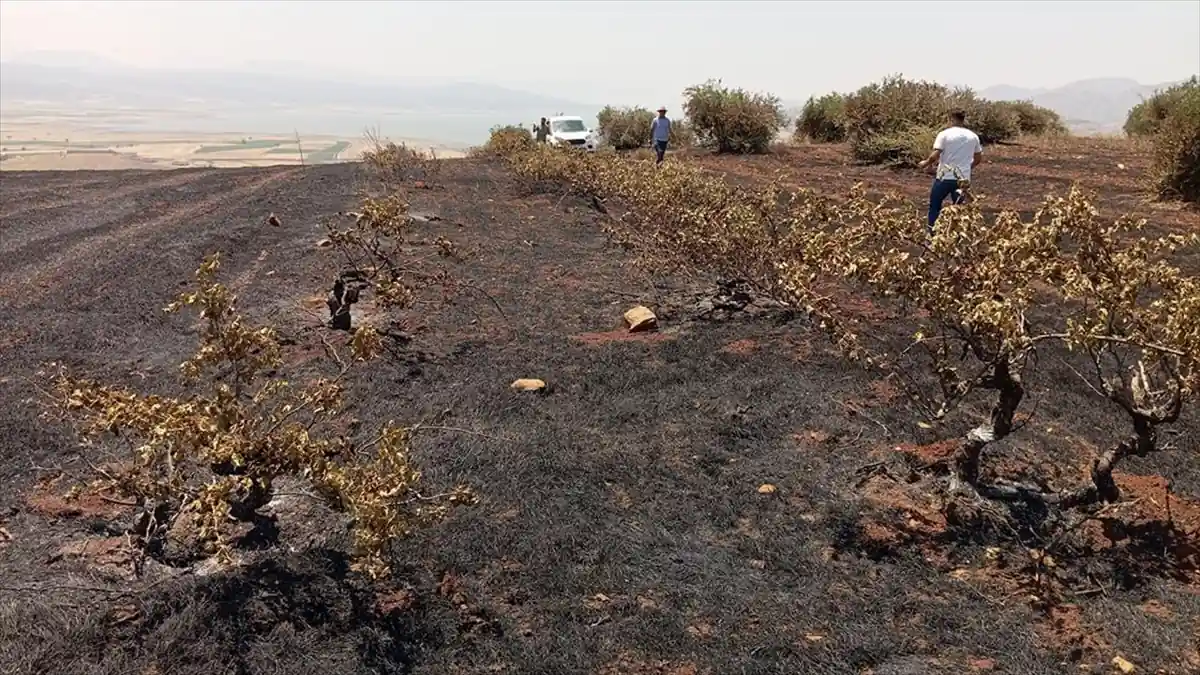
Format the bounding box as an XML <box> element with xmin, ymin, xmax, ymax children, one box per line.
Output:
<box><xmin>48</xmin><ymin>145</ymin><xmax>474</xmax><ymax>577</ymax></box>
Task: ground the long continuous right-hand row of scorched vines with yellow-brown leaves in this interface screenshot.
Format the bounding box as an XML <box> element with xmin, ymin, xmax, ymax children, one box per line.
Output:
<box><xmin>492</xmin><ymin>148</ymin><xmax>1200</xmax><ymax>528</ymax></box>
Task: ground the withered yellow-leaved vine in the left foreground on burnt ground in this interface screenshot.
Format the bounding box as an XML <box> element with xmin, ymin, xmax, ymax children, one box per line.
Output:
<box><xmin>53</xmin><ymin>256</ymin><xmax>472</xmax><ymax>575</ymax></box>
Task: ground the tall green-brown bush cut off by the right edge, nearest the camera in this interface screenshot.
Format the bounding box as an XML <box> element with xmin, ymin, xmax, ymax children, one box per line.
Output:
<box><xmin>1151</xmin><ymin>80</ymin><xmax>1200</xmax><ymax>203</ymax></box>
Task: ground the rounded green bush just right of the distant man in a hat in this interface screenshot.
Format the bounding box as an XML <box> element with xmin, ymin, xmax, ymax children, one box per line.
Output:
<box><xmin>684</xmin><ymin>79</ymin><xmax>787</xmax><ymax>154</ymax></box>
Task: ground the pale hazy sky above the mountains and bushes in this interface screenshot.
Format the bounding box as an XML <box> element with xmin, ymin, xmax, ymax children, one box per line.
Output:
<box><xmin>0</xmin><ymin>0</ymin><xmax>1200</xmax><ymax>104</ymax></box>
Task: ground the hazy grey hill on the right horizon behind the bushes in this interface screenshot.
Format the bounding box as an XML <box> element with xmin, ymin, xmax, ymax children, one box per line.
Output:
<box><xmin>979</xmin><ymin>78</ymin><xmax>1176</xmax><ymax>132</ymax></box>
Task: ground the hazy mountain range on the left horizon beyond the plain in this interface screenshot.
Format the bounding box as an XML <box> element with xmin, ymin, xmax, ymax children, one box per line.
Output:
<box><xmin>0</xmin><ymin>52</ymin><xmax>602</xmax><ymax>144</ymax></box>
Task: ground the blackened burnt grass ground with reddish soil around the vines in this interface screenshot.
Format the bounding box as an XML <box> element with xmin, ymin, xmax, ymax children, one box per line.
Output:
<box><xmin>0</xmin><ymin>142</ymin><xmax>1200</xmax><ymax>675</ymax></box>
